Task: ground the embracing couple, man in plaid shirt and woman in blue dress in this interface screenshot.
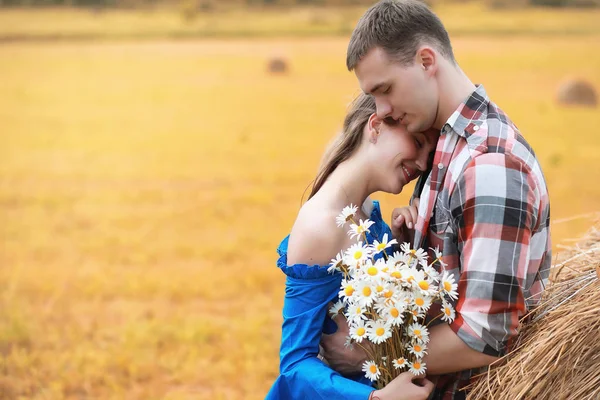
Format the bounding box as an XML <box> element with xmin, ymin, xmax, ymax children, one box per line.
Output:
<box><xmin>266</xmin><ymin>0</ymin><xmax>551</xmax><ymax>400</ymax></box>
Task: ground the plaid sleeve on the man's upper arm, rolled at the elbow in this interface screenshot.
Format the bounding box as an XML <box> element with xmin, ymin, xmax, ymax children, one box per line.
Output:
<box><xmin>450</xmin><ymin>153</ymin><xmax>540</xmax><ymax>357</ymax></box>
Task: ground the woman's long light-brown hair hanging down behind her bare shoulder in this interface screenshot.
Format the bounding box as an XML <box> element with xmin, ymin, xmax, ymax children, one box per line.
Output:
<box><xmin>308</xmin><ymin>93</ymin><xmax>375</xmax><ymax>199</ymax></box>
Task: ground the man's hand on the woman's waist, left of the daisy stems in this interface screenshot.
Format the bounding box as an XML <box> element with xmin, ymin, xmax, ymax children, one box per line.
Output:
<box><xmin>321</xmin><ymin>314</ymin><xmax>367</xmax><ymax>376</ymax></box>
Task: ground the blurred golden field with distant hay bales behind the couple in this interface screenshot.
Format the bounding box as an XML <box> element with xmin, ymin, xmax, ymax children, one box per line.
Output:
<box><xmin>0</xmin><ymin>0</ymin><xmax>600</xmax><ymax>399</ymax></box>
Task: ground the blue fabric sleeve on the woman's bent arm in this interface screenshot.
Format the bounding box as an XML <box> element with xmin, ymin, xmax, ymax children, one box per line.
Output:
<box><xmin>266</xmin><ymin>275</ymin><xmax>374</xmax><ymax>400</ymax></box>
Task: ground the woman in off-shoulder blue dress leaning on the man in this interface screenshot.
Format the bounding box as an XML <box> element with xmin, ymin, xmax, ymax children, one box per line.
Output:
<box><xmin>267</xmin><ymin>94</ymin><xmax>435</xmax><ymax>400</ymax></box>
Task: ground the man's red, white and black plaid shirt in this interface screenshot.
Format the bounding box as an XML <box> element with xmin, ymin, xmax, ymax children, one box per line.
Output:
<box><xmin>414</xmin><ymin>86</ymin><xmax>551</xmax><ymax>400</ymax></box>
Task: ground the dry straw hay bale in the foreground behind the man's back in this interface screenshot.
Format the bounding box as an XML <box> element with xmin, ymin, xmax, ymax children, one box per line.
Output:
<box><xmin>468</xmin><ymin>224</ymin><xmax>600</xmax><ymax>400</ymax></box>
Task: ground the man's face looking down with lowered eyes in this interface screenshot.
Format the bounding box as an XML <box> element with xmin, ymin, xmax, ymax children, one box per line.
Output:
<box><xmin>355</xmin><ymin>47</ymin><xmax>438</xmax><ymax>133</ymax></box>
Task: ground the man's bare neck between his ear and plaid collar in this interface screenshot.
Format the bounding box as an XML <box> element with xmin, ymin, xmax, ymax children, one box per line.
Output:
<box><xmin>434</xmin><ymin>63</ymin><xmax>476</xmax><ymax>129</ymax></box>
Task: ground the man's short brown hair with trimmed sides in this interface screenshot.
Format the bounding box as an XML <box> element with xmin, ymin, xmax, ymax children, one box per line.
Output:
<box><xmin>346</xmin><ymin>0</ymin><xmax>456</xmax><ymax>71</ymax></box>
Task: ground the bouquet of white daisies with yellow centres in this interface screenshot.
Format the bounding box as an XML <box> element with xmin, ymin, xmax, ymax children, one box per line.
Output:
<box><xmin>328</xmin><ymin>205</ymin><xmax>457</xmax><ymax>387</ymax></box>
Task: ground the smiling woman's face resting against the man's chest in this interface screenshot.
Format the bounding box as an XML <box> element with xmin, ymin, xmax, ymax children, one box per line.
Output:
<box><xmin>369</xmin><ymin>117</ymin><xmax>439</xmax><ymax>194</ymax></box>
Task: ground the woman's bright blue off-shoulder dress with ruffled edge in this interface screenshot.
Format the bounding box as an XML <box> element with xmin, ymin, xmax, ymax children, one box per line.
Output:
<box><xmin>266</xmin><ymin>201</ymin><xmax>392</xmax><ymax>400</ymax></box>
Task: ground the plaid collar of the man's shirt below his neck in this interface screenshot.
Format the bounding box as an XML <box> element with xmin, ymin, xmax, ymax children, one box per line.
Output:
<box><xmin>441</xmin><ymin>85</ymin><xmax>490</xmax><ymax>140</ymax></box>
